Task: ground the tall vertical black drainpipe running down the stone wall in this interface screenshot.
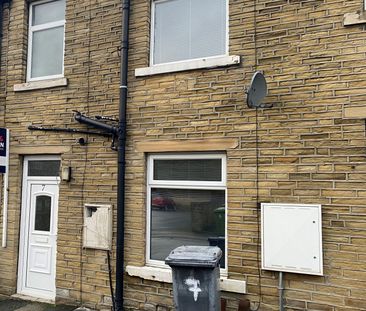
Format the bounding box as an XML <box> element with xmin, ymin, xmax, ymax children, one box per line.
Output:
<box><xmin>115</xmin><ymin>0</ymin><xmax>130</xmax><ymax>311</ymax></box>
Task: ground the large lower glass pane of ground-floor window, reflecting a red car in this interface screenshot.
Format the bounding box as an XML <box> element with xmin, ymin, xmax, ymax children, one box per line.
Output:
<box><xmin>150</xmin><ymin>188</ymin><xmax>225</xmax><ymax>267</ymax></box>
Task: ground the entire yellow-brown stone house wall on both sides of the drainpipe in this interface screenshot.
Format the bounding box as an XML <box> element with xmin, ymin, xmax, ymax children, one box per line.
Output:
<box><xmin>0</xmin><ymin>0</ymin><xmax>366</xmax><ymax>311</ymax></box>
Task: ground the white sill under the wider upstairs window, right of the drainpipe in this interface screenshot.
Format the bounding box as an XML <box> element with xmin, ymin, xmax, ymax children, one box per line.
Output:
<box><xmin>135</xmin><ymin>55</ymin><xmax>240</xmax><ymax>77</ymax></box>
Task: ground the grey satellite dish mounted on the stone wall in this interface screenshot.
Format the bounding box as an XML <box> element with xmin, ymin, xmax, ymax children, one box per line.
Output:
<box><xmin>246</xmin><ymin>71</ymin><xmax>272</xmax><ymax>108</ymax></box>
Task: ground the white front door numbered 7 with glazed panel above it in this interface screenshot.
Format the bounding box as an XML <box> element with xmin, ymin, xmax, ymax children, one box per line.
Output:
<box><xmin>18</xmin><ymin>157</ymin><xmax>60</xmax><ymax>300</ymax></box>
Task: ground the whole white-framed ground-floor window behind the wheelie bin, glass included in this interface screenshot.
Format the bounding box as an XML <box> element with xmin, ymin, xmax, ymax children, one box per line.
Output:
<box><xmin>147</xmin><ymin>154</ymin><xmax>226</xmax><ymax>268</ymax></box>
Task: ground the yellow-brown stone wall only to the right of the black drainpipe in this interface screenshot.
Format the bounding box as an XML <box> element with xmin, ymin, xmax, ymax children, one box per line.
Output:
<box><xmin>127</xmin><ymin>1</ymin><xmax>366</xmax><ymax>311</ymax></box>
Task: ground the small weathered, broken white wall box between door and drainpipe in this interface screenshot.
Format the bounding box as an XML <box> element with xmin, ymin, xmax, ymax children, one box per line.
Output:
<box><xmin>83</xmin><ymin>204</ymin><xmax>112</xmax><ymax>250</ymax></box>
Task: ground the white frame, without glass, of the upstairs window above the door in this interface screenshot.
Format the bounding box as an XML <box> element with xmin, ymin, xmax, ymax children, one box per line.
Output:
<box><xmin>27</xmin><ymin>0</ymin><xmax>66</xmax><ymax>82</ymax></box>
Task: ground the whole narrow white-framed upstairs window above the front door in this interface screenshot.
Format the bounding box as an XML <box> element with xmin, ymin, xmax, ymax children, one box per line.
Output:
<box><xmin>27</xmin><ymin>0</ymin><xmax>66</xmax><ymax>81</ymax></box>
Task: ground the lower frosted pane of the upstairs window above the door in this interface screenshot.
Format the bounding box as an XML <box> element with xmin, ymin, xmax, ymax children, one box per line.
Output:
<box><xmin>31</xmin><ymin>26</ymin><xmax>64</xmax><ymax>78</ymax></box>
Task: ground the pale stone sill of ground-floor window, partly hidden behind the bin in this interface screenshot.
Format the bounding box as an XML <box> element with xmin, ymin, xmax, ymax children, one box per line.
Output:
<box><xmin>126</xmin><ymin>265</ymin><xmax>247</xmax><ymax>294</ymax></box>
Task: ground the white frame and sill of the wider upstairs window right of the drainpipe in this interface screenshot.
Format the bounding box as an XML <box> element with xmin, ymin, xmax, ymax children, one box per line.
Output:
<box><xmin>135</xmin><ymin>0</ymin><xmax>240</xmax><ymax>77</ymax></box>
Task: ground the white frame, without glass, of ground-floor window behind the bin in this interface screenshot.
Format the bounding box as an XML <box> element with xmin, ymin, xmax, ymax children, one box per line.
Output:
<box><xmin>146</xmin><ymin>153</ymin><xmax>228</xmax><ymax>275</ymax></box>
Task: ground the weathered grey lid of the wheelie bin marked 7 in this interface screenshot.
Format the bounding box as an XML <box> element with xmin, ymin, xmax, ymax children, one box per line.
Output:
<box><xmin>165</xmin><ymin>246</ymin><xmax>222</xmax><ymax>268</ymax></box>
